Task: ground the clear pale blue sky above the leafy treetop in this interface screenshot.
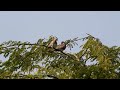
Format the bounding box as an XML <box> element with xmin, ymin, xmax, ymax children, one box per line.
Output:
<box><xmin>0</xmin><ymin>11</ymin><xmax>120</xmax><ymax>62</ymax></box>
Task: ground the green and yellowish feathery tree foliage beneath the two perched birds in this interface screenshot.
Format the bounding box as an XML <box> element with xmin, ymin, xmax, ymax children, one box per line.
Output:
<box><xmin>0</xmin><ymin>34</ymin><xmax>120</xmax><ymax>79</ymax></box>
